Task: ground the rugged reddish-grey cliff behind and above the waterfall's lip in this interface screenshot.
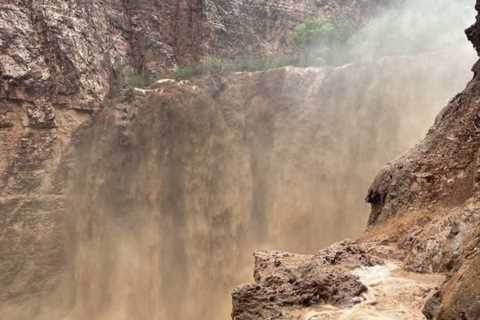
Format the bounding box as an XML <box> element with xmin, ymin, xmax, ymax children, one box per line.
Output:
<box><xmin>0</xmin><ymin>0</ymin><xmax>382</xmax><ymax>103</ymax></box>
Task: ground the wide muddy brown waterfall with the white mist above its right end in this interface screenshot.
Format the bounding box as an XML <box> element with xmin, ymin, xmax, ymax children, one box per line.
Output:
<box><xmin>18</xmin><ymin>0</ymin><xmax>475</xmax><ymax>320</ymax></box>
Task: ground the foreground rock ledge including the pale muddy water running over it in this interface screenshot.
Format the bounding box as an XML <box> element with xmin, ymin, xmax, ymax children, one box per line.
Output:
<box><xmin>232</xmin><ymin>241</ymin><xmax>445</xmax><ymax>320</ymax></box>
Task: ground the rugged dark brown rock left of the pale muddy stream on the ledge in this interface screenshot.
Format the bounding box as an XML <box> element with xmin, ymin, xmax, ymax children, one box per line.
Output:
<box><xmin>232</xmin><ymin>242</ymin><xmax>382</xmax><ymax>320</ymax></box>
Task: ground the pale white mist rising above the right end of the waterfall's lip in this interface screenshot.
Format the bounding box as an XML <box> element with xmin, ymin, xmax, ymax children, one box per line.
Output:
<box><xmin>344</xmin><ymin>0</ymin><xmax>475</xmax><ymax>61</ymax></box>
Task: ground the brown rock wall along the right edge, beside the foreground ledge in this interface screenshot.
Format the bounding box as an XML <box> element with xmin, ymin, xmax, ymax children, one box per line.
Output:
<box><xmin>367</xmin><ymin>1</ymin><xmax>480</xmax><ymax>320</ymax></box>
